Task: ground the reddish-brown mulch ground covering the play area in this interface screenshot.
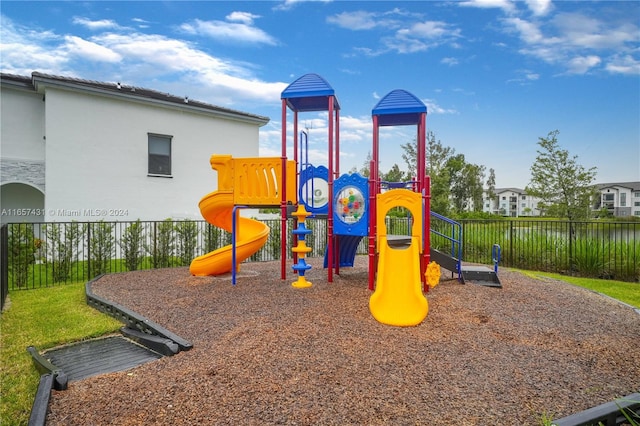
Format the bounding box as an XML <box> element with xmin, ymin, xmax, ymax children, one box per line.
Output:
<box><xmin>47</xmin><ymin>257</ymin><xmax>640</xmax><ymax>425</ymax></box>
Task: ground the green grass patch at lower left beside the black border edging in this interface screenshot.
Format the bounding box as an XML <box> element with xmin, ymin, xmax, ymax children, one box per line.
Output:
<box><xmin>0</xmin><ymin>283</ymin><xmax>122</xmax><ymax>425</ymax></box>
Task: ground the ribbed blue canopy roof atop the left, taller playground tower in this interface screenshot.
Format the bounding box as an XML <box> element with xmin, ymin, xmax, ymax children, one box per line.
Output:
<box><xmin>280</xmin><ymin>73</ymin><xmax>340</xmax><ymax>111</ymax></box>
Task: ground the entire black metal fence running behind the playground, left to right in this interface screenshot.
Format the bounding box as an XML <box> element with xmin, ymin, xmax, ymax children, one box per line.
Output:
<box><xmin>0</xmin><ymin>218</ymin><xmax>640</xmax><ymax>303</ymax></box>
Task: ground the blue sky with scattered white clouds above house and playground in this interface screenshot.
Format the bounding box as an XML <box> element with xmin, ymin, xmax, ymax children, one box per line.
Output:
<box><xmin>0</xmin><ymin>0</ymin><xmax>640</xmax><ymax>188</ymax></box>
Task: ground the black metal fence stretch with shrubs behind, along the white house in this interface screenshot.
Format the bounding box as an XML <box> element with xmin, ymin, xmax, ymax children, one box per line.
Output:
<box><xmin>1</xmin><ymin>219</ymin><xmax>338</xmax><ymax>290</ymax></box>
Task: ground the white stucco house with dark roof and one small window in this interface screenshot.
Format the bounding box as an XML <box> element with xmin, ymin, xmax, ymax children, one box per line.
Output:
<box><xmin>0</xmin><ymin>72</ymin><xmax>269</xmax><ymax>223</ymax></box>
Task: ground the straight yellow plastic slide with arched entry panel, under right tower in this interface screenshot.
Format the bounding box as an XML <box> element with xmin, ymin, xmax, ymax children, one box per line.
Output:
<box><xmin>369</xmin><ymin>189</ymin><xmax>429</xmax><ymax>326</ymax></box>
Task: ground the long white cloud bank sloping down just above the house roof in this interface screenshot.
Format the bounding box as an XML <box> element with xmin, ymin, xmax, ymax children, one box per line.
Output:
<box><xmin>0</xmin><ymin>16</ymin><xmax>287</xmax><ymax>106</ymax></box>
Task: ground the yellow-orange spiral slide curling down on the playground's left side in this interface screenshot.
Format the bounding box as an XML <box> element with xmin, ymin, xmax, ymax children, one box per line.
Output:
<box><xmin>189</xmin><ymin>191</ymin><xmax>269</xmax><ymax>276</ymax></box>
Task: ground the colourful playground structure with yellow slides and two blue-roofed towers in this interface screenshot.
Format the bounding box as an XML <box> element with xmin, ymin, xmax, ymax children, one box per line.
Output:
<box><xmin>190</xmin><ymin>74</ymin><xmax>500</xmax><ymax>326</ymax></box>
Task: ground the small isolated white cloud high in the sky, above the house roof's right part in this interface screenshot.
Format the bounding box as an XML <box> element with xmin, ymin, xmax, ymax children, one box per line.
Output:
<box><xmin>180</xmin><ymin>17</ymin><xmax>278</xmax><ymax>45</ymax></box>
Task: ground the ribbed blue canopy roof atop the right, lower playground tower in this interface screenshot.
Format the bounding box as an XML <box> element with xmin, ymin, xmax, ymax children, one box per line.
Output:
<box><xmin>371</xmin><ymin>89</ymin><xmax>427</xmax><ymax>126</ymax></box>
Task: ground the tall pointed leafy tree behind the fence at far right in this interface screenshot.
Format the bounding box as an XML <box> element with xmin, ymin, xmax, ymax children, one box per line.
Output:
<box><xmin>525</xmin><ymin>130</ymin><xmax>596</xmax><ymax>221</ymax></box>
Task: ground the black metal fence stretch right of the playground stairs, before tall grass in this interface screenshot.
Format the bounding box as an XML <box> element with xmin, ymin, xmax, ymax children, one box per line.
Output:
<box><xmin>461</xmin><ymin>220</ymin><xmax>640</xmax><ymax>282</ymax></box>
